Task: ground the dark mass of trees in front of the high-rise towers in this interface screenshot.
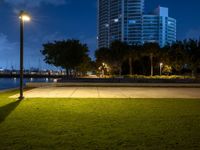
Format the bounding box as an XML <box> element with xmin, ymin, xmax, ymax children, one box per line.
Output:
<box><xmin>95</xmin><ymin>39</ymin><xmax>200</xmax><ymax>75</ymax></box>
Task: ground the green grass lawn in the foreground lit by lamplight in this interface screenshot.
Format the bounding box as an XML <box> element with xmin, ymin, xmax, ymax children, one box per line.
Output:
<box><xmin>0</xmin><ymin>91</ymin><xmax>200</xmax><ymax>150</ymax></box>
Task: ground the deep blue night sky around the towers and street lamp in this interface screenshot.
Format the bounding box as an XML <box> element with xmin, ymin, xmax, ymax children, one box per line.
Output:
<box><xmin>0</xmin><ymin>0</ymin><xmax>200</xmax><ymax>69</ymax></box>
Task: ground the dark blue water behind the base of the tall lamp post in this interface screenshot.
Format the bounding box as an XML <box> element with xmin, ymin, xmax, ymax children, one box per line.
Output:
<box><xmin>0</xmin><ymin>78</ymin><xmax>54</xmax><ymax>90</ymax></box>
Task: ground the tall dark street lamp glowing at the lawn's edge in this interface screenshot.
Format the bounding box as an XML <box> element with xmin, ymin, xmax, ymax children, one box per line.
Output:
<box><xmin>19</xmin><ymin>11</ymin><xmax>31</xmax><ymax>100</ymax></box>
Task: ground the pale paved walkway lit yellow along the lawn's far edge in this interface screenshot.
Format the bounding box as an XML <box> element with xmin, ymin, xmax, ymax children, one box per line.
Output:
<box><xmin>11</xmin><ymin>87</ymin><xmax>200</xmax><ymax>98</ymax></box>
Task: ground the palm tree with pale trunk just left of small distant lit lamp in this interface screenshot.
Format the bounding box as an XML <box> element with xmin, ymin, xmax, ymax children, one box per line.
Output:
<box><xmin>143</xmin><ymin>43</ymin><xmax>160</xmax><ymax>76</ymax></box>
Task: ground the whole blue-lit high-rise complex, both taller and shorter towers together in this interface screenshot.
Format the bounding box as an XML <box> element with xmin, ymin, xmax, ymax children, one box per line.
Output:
<box><xmin>98</xmin><ymin>0</ymin><xmax>176</xmax><ymax>48</ymax></box>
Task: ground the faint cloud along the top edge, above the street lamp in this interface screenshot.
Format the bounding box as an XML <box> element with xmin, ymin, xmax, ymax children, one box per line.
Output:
<box><xmin>4</xmin><ymin>0</ymin><xmax>69</xmax><ymax>7</ymax></box>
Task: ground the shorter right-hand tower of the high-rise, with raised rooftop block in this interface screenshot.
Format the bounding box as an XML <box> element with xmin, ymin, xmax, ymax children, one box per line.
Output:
<box><xmin>143</xmin><ymin>7</ymin><xmax>176</xmax><ymax>47</ymax></box>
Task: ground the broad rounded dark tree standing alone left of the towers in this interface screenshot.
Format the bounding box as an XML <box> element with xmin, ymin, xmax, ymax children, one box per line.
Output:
<box><xmin>41</xmin><ymin>39</ymin><xmax>89</xmax><ymax>76</ymax></box>
